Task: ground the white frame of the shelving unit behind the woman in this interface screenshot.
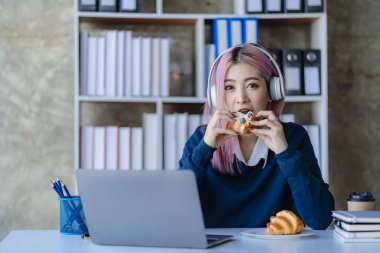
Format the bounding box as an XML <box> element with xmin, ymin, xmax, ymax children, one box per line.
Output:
<box><xmin>74</xmin><ymin>0</ymin><xmax>328</xmax><ymax>182</ymax></box>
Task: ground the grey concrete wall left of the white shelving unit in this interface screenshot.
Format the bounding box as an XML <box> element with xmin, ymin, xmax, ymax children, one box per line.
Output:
<box><xmin>0</xmin><ymin>0</ymin><xmax>74</xmax><ymax>239</ymax></box>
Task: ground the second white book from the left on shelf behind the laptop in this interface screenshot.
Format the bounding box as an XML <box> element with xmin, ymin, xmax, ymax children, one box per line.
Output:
<box><xmin>93</xmin><ymin>127</ymin><xmax>106</xmax><ymax>170</ymax></box>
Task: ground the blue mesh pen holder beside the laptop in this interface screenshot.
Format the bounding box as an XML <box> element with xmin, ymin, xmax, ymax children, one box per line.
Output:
<box><xmin>59</xmin><ymin>196</ymin><xmax>88</xmax><ymax>235</ymax></box>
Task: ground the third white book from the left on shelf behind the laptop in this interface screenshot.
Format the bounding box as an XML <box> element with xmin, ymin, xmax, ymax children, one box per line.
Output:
<box><xmin>106</xmin><ymin>126</ymin><xmax>119</xmax><ymax>170</ymax></box>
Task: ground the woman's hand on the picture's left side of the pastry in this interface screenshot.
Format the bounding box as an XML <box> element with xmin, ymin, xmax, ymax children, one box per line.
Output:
<box><xmin>203</xmin><ymin>110</ymin><xmax>237</xmax><ymax>148</ymax></box>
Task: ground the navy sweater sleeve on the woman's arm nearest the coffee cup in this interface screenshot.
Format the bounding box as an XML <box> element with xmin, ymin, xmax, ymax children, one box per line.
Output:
<box><xmin>276</xmin><ymin>126</ymin><xmax>334</xmax><ymax>229</ymax></box>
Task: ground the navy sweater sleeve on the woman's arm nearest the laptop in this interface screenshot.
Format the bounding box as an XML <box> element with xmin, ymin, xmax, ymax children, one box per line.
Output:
<box><xmin>179</xmin><ymin>126</ymin><xmax>216</xmax><ymax>185</ymax></box>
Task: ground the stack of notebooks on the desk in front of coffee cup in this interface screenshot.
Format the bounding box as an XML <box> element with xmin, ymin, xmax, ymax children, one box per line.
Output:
<box><xmin>333</xmin><ymin>211</ymin><xmax>380</xmax><ymax>242</ymax></box>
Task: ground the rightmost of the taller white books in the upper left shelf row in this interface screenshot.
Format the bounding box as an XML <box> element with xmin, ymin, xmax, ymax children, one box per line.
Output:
<box><xmin>124</xmin><ymin>31</ymin><xmax>133</xmax><ymax>97</ymax></box>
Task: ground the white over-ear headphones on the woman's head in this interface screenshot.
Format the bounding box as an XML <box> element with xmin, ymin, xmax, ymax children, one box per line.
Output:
<box><xmin>207</xmin><ymin>43</ymin><xmax>285</xmax><ymax>108</ymax></box>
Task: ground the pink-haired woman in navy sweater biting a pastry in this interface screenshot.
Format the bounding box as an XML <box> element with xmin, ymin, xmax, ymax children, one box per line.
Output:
<box><xmin>179</xmin><ymin>44</ymin><xmax>334</xmax><ymax>229</ymax></box>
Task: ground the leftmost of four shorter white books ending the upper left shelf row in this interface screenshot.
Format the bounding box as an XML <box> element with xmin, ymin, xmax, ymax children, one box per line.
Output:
<box><xmin>132</xmin><ymin>37</ymin><xmax>142</xmax><ymax>96</ymax></box>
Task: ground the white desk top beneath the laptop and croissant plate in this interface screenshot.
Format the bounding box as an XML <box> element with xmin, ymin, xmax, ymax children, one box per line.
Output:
<box><xmin>0</xmin><ymin>228</ymin><xmax>380</xmax><ymax>253</ymax></box>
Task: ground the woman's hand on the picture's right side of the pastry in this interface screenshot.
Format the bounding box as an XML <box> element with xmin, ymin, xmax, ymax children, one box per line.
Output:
<box><xmin>251</xmin><ymin>111</ymin><xmax>288</xmax><ymax>154</ymax></box>
